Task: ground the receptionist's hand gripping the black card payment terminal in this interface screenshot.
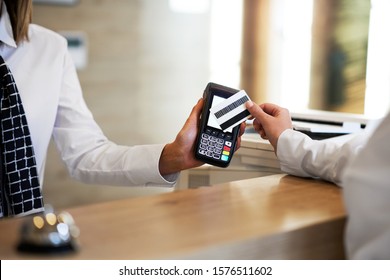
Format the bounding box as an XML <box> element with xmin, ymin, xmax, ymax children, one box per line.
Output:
<box><xmin>159</xmin><ymin>98</ymin><xmax>245</xmax><ymax>176</ymax></box>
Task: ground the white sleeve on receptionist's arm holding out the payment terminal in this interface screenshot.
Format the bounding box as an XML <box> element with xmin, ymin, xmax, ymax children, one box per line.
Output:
<box><xmin>53</xmin><ymin>40</ymin><xmax>178</xmax><ymax>186</ymax></box>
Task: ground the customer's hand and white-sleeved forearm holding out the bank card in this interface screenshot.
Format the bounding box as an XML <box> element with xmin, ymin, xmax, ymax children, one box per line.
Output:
<box><xmin>247</xmin><ymin>102</ymin><xmax>372</xmax><ymax>184</ymax></box>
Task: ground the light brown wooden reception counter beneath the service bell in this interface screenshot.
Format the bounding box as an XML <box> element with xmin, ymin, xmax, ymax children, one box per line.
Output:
<box><xmin>0</xmin><ymin>174</ymin><xmax>346</xmax><ymax>260</ymax></box>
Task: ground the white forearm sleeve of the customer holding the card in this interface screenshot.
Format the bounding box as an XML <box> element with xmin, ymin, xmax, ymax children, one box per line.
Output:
<box><xmin>277</xmin><ymin>129</ymin><xmax>367</xmax><ymax>185</ymax></box>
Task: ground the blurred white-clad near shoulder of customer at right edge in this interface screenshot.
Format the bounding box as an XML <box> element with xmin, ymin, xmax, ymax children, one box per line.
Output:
<box><xmin>343</xmin><ymin>112</ymin><xmax>390</xmax><ymax>259</ymax></box>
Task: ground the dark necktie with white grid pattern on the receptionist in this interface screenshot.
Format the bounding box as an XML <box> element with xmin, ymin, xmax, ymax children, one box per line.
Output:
<box><xmin>0</xmin><ymin>56</ymin><xmax>43</xmax><ymax>218</ymax></box>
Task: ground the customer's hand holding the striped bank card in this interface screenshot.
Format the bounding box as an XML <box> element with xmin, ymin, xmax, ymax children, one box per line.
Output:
<box><xmin>246</xmin><ymin>101</ymin><xmax>292</xmax><ymax>152</ymax></box>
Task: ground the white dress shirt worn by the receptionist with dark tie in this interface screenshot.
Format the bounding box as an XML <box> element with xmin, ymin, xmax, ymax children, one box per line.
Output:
<box><xmin>0</xmin><ymin>3</ymin><xmax>178</xmax><ymax>186</ymax></box>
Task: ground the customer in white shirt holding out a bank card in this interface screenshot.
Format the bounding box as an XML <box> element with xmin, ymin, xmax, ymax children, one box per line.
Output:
<box><xmin>247</xmin><ymin>99</ymin><xmax>390</xmax><ymax>259</ymax></box>
